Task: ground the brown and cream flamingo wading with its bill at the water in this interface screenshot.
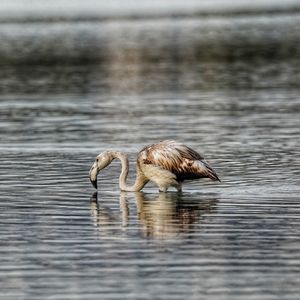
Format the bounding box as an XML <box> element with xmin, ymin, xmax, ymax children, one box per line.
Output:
<box><xmin>89</xmin><ymin>140</ymin><xmax>220</xmax><ymax>192</ymax></box>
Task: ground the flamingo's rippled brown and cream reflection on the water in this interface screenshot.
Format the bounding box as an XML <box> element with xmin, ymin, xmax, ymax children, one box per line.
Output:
<box><xmin>91</xmin><ymin>192</ymin><xmax>218</xmax><ymax>238</ymax></box>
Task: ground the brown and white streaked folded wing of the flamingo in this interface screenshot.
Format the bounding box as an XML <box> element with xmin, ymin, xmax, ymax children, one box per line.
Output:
<box><xmin>139</xmin><ymin>140</ymin><xmax>219</xmax><ymax>181</ymax></box>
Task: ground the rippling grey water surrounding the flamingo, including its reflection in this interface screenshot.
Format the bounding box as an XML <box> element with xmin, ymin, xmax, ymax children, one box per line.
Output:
<box><xmin>0</xmin><ymin>7</ymin><xmax>300</xmax><ymax>299</ymax></box>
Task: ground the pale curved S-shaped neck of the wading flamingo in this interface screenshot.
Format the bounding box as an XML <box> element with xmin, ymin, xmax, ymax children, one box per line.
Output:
<box><xmin>113</xmin><ymin>151</ymin><xmax>149</xmax><ymax>192</ymax></box>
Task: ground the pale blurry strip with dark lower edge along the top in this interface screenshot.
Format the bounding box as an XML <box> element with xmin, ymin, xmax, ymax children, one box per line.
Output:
<box><xmin>0</xmin><ymin>0</ymin><xmax>300</xmax><ymax>23</ymax></box>
